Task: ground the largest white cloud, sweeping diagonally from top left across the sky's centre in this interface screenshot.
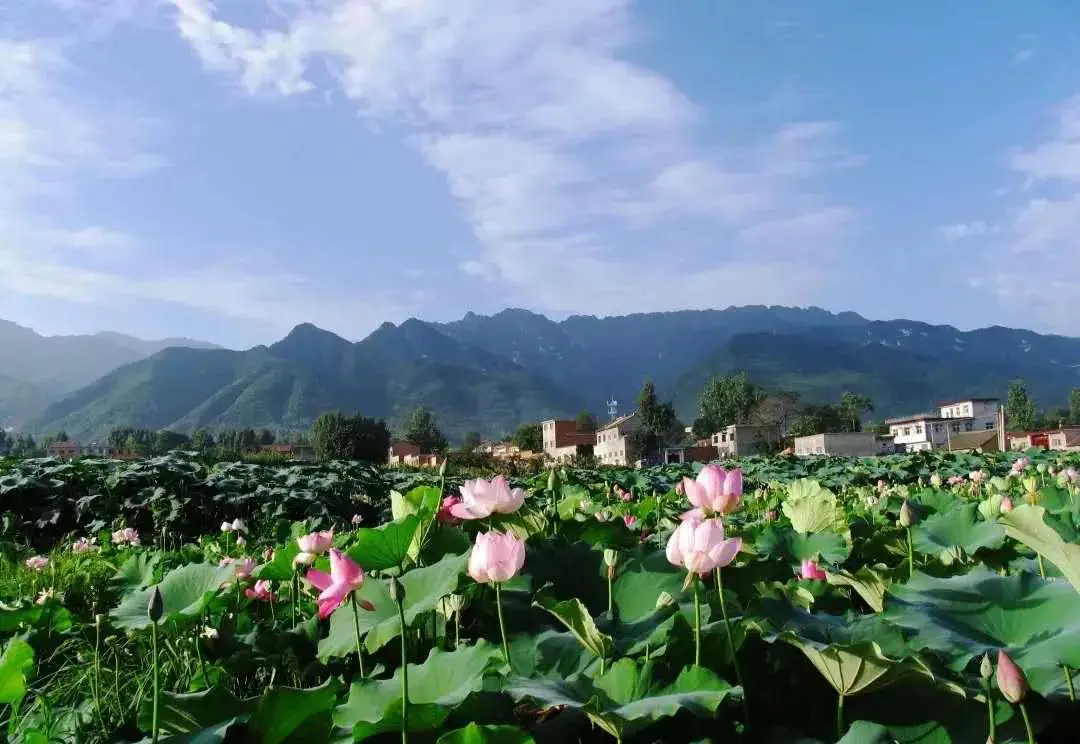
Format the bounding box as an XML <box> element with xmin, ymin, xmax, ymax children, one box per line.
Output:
<box><xmin>172</xmin><ymin>0</ymin><xmax>859</xmax><ymax>311</ymax></box>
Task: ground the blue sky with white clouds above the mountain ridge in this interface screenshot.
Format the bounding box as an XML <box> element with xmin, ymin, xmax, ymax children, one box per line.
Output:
<box><xmin>0</xmin><ymin>0</ymin><xmax>1080</xmax><ymax>347</ymax></box>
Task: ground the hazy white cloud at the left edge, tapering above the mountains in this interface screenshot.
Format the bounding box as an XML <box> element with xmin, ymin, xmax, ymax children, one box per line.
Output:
<box><xmin>0</xmin><ymin>31</ymin><xmax>406</xmax><ymax>335</ymax></box>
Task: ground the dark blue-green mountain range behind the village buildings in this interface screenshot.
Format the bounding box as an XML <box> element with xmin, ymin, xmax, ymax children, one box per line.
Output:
<box><xmin>8</xmin><ymin>306</ymin><xmax>1080</xmax><ymax>439</ymax></box>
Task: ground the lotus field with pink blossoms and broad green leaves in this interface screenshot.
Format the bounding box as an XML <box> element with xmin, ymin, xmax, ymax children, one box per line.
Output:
<box><xmin>0</xmin><ymin>452</ymin><xmax>1080</xmax><ymax>744</ymax></box>
